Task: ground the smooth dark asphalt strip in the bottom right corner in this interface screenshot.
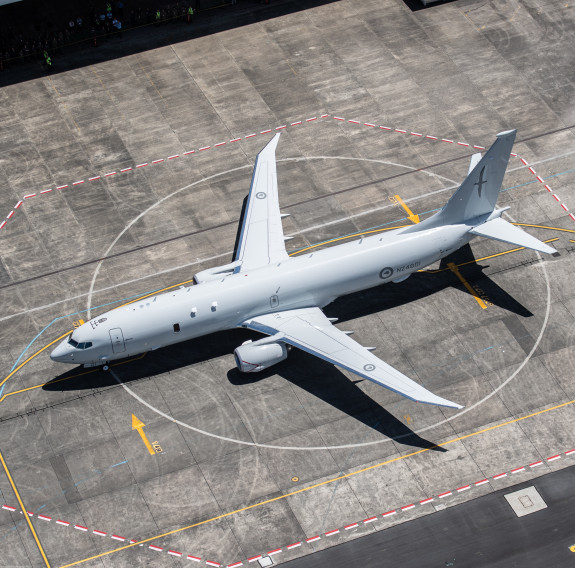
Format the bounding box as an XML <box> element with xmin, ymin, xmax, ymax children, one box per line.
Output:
<box><xmin>286</xmin><ymin>466</ymin><xmax>575</xmax><ymax>568</ymax></box>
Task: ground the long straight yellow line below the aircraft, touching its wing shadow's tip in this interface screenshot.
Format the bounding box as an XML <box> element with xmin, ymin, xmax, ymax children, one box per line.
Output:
<box><xmin>60</xmin><ymin>399</ymin><xmax>575</xmax><ymax>568</ymax></box>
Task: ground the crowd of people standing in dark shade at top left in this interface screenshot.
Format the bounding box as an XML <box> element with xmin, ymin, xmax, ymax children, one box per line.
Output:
<box><xmin>0</xmin><ymin>0</ymin><xmax>201</xmax><ymax>71</ymax></box>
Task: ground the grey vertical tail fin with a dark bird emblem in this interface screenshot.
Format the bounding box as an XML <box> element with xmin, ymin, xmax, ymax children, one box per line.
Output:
<box><xmin>440</xmin><ymin>130</ymin><xmax>517</xmax><ymax>224</ymax></box>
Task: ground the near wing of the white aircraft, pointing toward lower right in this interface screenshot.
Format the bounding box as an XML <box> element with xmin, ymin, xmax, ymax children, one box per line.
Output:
<box><xmin>242</xmin><ymin>307</ymin><xmax>463</xmax><ymax>409</ymax></box>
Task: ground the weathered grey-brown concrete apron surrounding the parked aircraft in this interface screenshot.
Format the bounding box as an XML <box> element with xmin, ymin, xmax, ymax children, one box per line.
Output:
<box><xmin>0</xmin><ymin>0</ymin><xmax>575</xmax><ymax>567</ymax></box>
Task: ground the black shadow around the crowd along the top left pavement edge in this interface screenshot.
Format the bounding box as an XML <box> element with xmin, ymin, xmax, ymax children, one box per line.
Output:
<box><xmin>0</xmin><ymin>0</ymin><xmax>342</xmax><ymax>86</ymax></box>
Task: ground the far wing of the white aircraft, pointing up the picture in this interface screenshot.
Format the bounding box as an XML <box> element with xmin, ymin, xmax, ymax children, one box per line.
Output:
<box><xmin>234</xmin><ymin>134</ymin><xmax>288</xmax><ymax>272</ymax></box>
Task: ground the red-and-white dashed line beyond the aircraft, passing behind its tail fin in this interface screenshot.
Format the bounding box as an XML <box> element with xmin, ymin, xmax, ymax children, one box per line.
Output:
<box><xmin>0</xmin><ymin>114</ymin><xmax>575</xmax><ymax>233</ymax></box>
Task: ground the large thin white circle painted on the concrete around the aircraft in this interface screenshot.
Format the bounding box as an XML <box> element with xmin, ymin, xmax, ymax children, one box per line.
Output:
<box><xmin>87</xmin><ymin>156</ymin><xmax>551</xmax><ymax>451</ymax></box>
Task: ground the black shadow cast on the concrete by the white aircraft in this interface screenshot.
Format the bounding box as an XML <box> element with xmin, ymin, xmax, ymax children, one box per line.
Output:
<box><xmin>43</xmin><ymin>245</ymin><xmax>533</xmax><ymax>451</ymax></box>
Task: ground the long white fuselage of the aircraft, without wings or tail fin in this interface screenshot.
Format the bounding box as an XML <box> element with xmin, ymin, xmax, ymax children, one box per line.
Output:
<box><xmin>51</xmin><ymin>220</ymin><xmax>473</xmax><ymax>365</ymax></box>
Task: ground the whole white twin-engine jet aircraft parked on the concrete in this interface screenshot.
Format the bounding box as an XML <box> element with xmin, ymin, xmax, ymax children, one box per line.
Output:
<box><xmin>50</xmin><ymin>130</ymin><xmax>556</xmax><ymax>408</ymax></box>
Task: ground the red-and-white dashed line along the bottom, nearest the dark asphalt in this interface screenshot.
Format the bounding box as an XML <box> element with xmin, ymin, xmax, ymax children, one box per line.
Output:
<box><xmin>1</xmin><ymin>449</ymin><xmax>575</xmax><ymax>568</ymax></box>
